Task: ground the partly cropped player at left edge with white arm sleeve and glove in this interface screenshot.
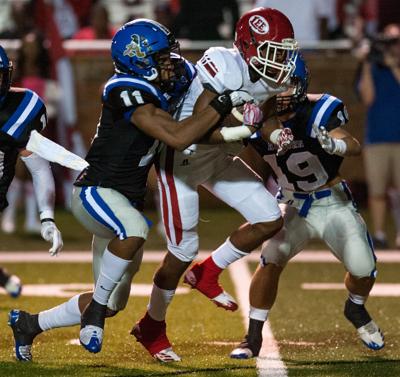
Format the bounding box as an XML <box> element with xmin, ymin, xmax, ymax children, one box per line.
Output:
<box><xmin>0</xmin><ymin>46</ymin><xmax>63</xmax><ymax>297</ymax></box>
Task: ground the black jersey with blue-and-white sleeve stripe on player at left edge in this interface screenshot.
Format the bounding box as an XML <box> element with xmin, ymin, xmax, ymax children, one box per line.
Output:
<box><xmin>0</xmin><ymin>88</ymin><xmax>47</xmax><ymax>211</ymax></box>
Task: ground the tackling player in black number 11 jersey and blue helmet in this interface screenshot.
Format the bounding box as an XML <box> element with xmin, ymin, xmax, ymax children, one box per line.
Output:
<box><xmin>10</xmin><ymin>19</ymin><xmax>252</xmax><ymax>360</ymax></box>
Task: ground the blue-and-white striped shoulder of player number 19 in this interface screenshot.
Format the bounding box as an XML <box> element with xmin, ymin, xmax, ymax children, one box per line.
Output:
<box><xmin>307</xmin><ymin>93</ymin><xmax>348</xmax><ymax>137</ymax></box>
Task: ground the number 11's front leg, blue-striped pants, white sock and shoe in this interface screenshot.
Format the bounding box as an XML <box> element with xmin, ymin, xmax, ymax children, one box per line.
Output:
<box><xmin>72</xmin><ymin>187</ymin><xmax>148</xmax><ymax>352</ymax></box>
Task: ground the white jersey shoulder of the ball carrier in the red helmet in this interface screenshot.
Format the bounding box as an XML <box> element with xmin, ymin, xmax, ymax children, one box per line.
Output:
<box><xmin>196</xmin><ymin>47</ymin><xmax>243</xmax><ymax>93</ymax></box>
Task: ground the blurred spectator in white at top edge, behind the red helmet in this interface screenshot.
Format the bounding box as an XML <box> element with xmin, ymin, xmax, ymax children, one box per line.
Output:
<box><xmin>255</xmin><ymin>0</ymin><xmax>336</xmax><ymax>44</ymax></box>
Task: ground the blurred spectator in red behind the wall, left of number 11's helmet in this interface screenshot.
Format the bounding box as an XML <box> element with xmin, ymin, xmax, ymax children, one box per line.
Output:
<box><xmin>73</xmin><ymin>4</ymin><xmax>116</xmax><ymax>40</ymax></box>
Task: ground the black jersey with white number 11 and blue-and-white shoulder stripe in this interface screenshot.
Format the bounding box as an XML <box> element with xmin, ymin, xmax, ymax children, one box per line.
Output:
<box><xmin>75</xmin><ymin>57</ymin><xmax>195</xmax><ymax>205</ymax></box>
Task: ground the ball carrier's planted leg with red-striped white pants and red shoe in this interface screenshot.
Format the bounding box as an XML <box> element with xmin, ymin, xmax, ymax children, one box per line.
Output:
<box><xmin>131</xmin><ymin>150</ymin><xmax>206</xmax><ymax>362</ymax></box>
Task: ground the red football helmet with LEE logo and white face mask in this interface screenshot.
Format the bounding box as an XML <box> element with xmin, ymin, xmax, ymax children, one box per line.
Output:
<box><xmin>234</xmin><ymin>8</ymin><xmax>298</xmax><ymax>85</ymax></box>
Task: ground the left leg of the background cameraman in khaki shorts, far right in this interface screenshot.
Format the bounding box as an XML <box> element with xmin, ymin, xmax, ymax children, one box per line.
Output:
<box><xmin>364</xmin><ymin>144</ymin><xmax>390</xmax><ymax>249</ymax></box>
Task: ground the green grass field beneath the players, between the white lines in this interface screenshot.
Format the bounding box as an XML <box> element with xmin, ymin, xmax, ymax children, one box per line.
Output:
<box><xmin>0</xmin><ymin>210</ymin><xmax>400</xmax><ymax>377</ymax></box>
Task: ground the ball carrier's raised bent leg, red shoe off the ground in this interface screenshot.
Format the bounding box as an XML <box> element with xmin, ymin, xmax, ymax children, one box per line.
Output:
<box><xmin>185</xmin><ymin>156</ymin><xmax>283</xmax><ymax>310</ymax></box>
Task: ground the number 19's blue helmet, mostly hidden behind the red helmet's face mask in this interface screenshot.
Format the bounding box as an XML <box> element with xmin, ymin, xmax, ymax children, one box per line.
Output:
<box><xmin>276</xmin><ymin>54</ymin><xmax>310</xmax><ymax>115</ymax></box>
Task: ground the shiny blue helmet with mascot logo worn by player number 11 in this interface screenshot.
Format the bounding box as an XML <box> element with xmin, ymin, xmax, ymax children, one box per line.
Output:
<box><xmin>111</xmin><ymin>18</ymin><xmax>179</xmax><ymax>81</ymax></box>
